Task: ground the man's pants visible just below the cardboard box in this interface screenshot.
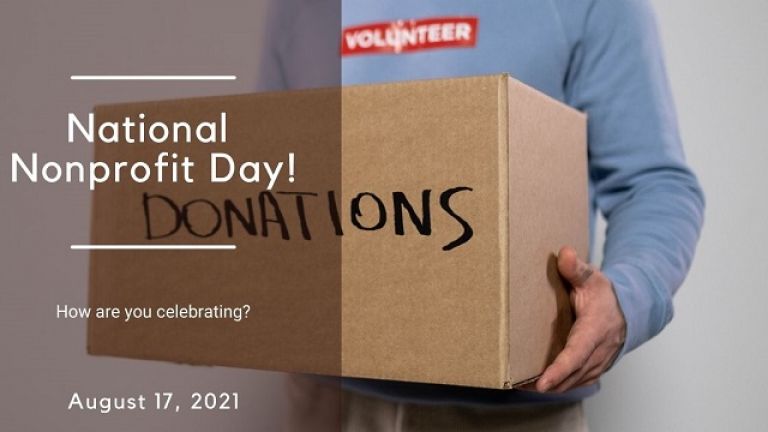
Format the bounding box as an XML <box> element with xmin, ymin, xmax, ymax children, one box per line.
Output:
<box><xmin>287</xmin><ymin>374</ymin><xmax>588</xmax><ymax>432</ymax></box>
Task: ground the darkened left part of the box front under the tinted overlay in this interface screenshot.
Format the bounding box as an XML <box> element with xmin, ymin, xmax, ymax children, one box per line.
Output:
<box><xmin>88</xmin><ymin>90</ymin><xmax>341</xmax><ymax>374</ymax></box>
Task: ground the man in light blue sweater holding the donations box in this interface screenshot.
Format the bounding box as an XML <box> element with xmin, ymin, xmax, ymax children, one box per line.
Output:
<box><xmin>261</xmin><ymin>0</ymin><xmax>704</xmax><ymax>431</ymax></box>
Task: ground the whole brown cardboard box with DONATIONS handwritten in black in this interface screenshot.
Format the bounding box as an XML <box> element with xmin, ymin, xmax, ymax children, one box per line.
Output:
<box><xmin>88</xmin><ymin>75</ymin><xmax>588</xmax><ymax>388</ymax></box>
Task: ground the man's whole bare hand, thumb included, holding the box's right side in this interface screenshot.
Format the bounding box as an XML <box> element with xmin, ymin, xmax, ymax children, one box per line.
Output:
<box><xmin>536</xmin><ymin>246</ymin><xmax>627</xmax><ymax>392</ymax></box>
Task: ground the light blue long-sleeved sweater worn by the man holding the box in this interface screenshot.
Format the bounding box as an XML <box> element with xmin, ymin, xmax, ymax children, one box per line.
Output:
<box><xmin>260</xmin><ymin>0</ymin><xmax>704</xmax><ymax>404</ymax></box>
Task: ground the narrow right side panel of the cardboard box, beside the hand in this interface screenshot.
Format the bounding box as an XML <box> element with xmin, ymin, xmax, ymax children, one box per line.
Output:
<box><xmin>508</xmin><ymin>79</ymin><xmax>589</xmax><ymax>384</ymax></box>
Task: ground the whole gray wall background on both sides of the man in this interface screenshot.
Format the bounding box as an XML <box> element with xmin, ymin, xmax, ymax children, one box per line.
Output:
<box><xmin>0</xmin><ymin>0</ymin><xmax>768</xmax><ymax>432</ymax></box>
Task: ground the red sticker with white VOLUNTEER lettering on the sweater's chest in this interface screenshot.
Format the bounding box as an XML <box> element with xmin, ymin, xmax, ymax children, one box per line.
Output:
<box><xmin>341</xmin><ymin>17</ymin><xmax>477</xmax><ymax>56</ymax></box>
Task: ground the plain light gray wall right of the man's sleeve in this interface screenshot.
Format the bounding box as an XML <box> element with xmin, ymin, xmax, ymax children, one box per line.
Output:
<box><xmin>587</xmin><ymin>0</ymin><xmax>768</xmax><ymax>432</ymax></box>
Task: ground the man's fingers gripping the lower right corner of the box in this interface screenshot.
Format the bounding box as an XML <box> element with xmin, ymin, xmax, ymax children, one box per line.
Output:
<box><xmin>536</xmin><ymin>321</ymin><xmax>597</xmax><ymax>392</ymax></box>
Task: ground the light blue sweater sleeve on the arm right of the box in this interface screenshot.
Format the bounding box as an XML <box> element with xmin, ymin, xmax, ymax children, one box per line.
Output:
<box><xmin>565</xmin><ymin>0</ymin><xmax>704</xmax><ymax>356</ymax></box>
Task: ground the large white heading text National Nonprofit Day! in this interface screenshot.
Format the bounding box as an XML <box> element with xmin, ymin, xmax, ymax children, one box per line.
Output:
<box><xmin>11</xmin><ymin>112</ymin><xmax>295</xmax><ymax>190</ymax></box>
